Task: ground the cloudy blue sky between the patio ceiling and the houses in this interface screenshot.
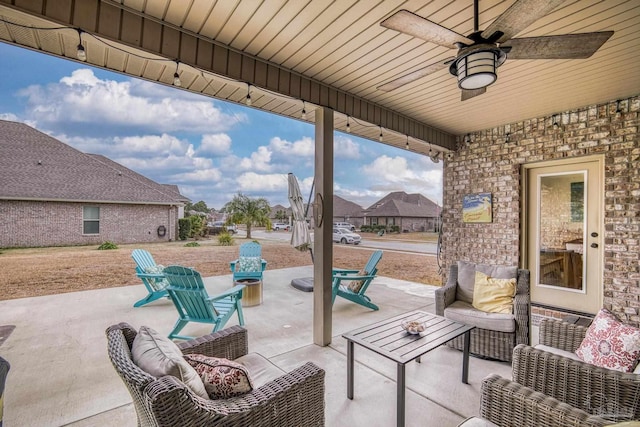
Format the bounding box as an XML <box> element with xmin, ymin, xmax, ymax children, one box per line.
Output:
<box><xmin>0</xmin><ymin>43</ymin><xmax>442</xmax><ymax>209</ymax></box>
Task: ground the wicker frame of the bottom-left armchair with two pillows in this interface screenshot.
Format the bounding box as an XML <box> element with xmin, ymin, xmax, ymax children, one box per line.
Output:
<box><xmin>106</xmin><ymin>323</ymin><xmax>325</xmax><ymax>427</ymax></box>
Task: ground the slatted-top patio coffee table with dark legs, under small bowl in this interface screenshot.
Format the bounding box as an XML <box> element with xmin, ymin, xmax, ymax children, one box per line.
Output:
<box><xmin>342</xmin><ymin>311</ymin><xmax>475</xmax><ymax>427</ymax></box>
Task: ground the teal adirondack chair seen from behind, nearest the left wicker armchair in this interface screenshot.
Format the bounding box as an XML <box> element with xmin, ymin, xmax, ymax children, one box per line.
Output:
<box><xmin>164</xmin><ymin>265</ymin><xmax>244</xmax><ymax>340</ymax></box>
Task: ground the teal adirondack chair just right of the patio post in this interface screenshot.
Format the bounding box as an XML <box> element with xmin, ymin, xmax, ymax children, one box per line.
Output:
<box><xmin>331</xmin><ymin>251</ymin><xmax>382</xmax><ymax>310</ymax></box>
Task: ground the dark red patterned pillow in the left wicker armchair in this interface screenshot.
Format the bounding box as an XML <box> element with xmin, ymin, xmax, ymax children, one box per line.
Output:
<box><xmin>184</xmin><ymin>354</ymin><xmax>253</xmax><ymax>399</ymax></box>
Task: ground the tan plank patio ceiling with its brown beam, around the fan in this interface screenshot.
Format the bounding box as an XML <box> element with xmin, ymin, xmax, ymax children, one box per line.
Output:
<box><xmin>0</xmin><ymin>0</ymin><xmax>640</xmax><ymax>154</ymax></box>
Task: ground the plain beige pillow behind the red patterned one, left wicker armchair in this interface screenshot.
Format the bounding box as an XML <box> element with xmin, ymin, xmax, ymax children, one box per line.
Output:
<box><xmin>131</xmin><ymin>326</ymin><xmax>209</xmax><ymax>399</ymax></box>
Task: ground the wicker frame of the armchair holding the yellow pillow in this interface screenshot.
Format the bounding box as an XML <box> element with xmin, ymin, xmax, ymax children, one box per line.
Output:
<box><xmin>435</xmin><ymin>263</ymin><xmax>530</xmax><ymax>362</ymax></box>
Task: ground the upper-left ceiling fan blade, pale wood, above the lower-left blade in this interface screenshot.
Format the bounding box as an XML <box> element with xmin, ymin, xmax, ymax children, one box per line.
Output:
<box><xmin>380</xmin><ymin>9</ymin><xmax>473</xmax><ymax>49</ymax></box>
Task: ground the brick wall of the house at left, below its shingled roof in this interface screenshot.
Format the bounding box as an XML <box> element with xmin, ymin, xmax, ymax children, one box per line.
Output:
<box><xmin>0</xmin><ymin>200</ymin><xmax>177</xmax><ymax>248</ymax></box>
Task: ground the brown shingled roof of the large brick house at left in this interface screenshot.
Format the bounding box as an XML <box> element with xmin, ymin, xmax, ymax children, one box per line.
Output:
<box><xmin>0</xmin><ymin>120</ymin><xmax>188</xmax><ymax>204</ymax></box>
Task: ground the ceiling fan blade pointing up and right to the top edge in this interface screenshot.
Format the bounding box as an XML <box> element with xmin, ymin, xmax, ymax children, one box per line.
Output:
<box><xmin>482</xmin><ymin>0</ymin><xmax>565</xmax><ymax>43</ymax></box>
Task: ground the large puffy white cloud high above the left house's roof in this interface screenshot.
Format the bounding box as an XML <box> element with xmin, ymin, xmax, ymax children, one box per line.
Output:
<box><xmin>19</xmin><ymin>69</ymin><xmax>246</xmax><ymax>133</ymax></box>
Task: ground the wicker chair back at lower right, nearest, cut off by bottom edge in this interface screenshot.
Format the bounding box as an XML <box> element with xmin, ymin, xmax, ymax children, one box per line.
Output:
<box><xmin>472</xmin><ymin>374</ymin><xmax>611</xmax><ymax>427</ymax></box>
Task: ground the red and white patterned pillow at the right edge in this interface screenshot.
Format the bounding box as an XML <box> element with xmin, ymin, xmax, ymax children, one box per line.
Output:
<box><xmin>576</xmin><ymin>308</ymin><xmax>640</xmax><ymax>372</ymax></box>
